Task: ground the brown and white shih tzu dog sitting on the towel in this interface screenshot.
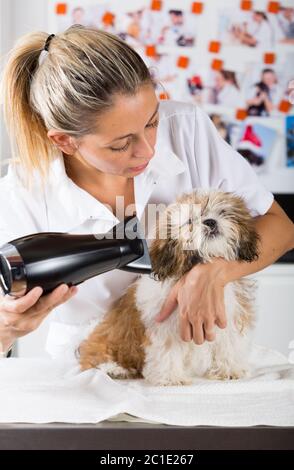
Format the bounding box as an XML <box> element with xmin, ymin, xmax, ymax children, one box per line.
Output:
<box><xmin>79</xmin><ymin>190</ymin><xmax>259</xmax><ymax>385</ymax></box>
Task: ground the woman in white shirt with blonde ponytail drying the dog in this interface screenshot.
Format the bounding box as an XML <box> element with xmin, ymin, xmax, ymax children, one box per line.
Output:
<box><xmin>0</xmin><ymin>26</ymin><xmax>294</xmax><ymax>357</ymax></box>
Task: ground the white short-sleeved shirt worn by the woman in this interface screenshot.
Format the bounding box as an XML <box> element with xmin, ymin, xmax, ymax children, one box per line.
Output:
<box><xmin>0</xmin><ymin>101</ymin><xmax>273</xmax><ymax>356</ymax></box>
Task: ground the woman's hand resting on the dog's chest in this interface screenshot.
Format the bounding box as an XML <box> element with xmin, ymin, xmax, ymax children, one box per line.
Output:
<box><xmin>156</xmin><ymin>258</ymin><xmax>227</xmax><ymax>344</ymax></box>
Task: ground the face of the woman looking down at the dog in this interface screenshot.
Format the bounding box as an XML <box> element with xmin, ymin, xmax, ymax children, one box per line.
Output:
<box><xmin>73</xmin><ymin>85</ymin><xmax>159</xmax><ymax>177</ymax></box>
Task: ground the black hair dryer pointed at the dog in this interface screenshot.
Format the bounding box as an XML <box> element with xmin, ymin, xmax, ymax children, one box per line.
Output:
<box><xmin>0</xmin><ymin>216</ymin><xmax>152</xmax><ymax>297</ymax></box>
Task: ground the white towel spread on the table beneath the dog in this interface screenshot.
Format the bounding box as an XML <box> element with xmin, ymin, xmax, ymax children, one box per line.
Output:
<box><xmin>0</xmin><ymin>346</ymin><xmax>294</xmax><ymax>426</ymax></box>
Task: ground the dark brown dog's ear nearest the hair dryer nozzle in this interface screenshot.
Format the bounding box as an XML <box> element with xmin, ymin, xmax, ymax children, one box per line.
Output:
<box><xmin>149</xmin><ymin>239</ymin><xmax>179</xmax><ymax>281</ymax></box>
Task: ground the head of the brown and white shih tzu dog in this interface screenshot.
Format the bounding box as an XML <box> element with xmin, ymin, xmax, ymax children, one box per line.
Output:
<box><xmin>150</xmin><ymin>190</ymin><xmax>258</xmax><ymax>280</ymax></box>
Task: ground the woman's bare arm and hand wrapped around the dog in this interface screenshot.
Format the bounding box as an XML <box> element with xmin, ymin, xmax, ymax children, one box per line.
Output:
<box><xmin>156</xmin><ymin>201</ymin><xmax>294</xmax><ymax>344</ymax></box>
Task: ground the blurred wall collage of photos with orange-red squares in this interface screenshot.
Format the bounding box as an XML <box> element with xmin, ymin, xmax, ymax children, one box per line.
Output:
<box><xmin>50</xmin><ymin>0</ymin><xmax>294</xmax><ymax>173</ymax></box>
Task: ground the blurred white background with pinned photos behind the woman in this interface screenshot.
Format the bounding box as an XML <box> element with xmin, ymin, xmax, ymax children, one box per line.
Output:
<box><xmin>0</xmin><ymin>0</ymin><xmax>294</xmax><ymax>356</ymax></box>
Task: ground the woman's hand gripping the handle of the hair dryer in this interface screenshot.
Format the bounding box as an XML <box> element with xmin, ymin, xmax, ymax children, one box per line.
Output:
<box><xmin>0</xmin><ymin>284</ymin><xmax>78</xmax><ymax>352</ymax></box>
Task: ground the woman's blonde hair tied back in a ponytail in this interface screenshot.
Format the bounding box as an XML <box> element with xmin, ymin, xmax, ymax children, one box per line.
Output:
<box><xmin>2</xmin><ymin>25</ymin><xmax>153</xmax><ymax>187</ymax></box>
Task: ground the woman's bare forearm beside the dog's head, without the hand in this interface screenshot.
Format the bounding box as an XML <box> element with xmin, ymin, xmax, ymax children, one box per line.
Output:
<box><xmin>217</xmin><ymin>209</ymin><xmax>294</xmax><ymax>283</ymax></box>
